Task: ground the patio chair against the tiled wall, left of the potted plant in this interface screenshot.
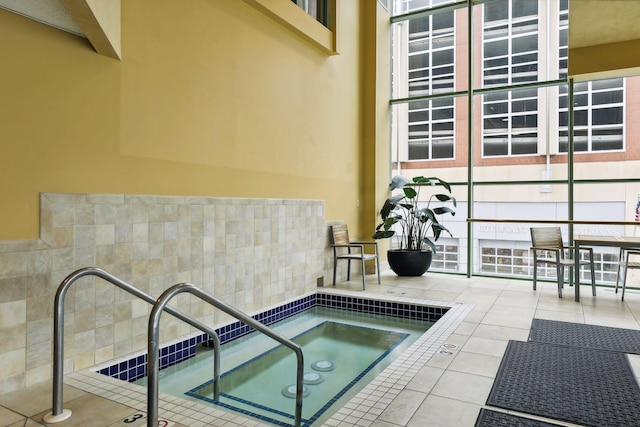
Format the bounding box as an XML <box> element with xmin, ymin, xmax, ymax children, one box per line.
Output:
<box><xmin>330</xmin><ymin>224</ymin><xmax>380</xmax><ymax>289</ymax></box>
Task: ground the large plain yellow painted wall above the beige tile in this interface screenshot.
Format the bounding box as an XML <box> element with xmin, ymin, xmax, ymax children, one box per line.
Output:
<box><xmin>0</xmin><ymin>0</ymin><xmax>369</xmax><ymax>240</ymax></box>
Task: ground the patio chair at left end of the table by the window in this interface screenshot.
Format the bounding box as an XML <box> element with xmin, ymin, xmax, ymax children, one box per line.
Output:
<box><xmin>531</xmin><ymin>227</ymin><xmax>596</xmax><ymax>298</ymax></box>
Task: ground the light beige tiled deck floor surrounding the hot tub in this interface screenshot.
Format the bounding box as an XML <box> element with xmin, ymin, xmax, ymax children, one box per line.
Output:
<box><xmin>0</xmin><ymin>272</ymin><xmax>640</xmax><ymax>427</ymax></box>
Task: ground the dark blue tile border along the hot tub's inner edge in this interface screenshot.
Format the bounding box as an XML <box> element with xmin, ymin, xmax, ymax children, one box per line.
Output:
<box><xmin>97</xmin><ymin>292</ymin><xmax>449</xmax><ymax>382</ymax></box>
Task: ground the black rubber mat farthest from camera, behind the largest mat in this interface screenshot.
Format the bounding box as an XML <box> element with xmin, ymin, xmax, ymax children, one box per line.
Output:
<box><xmin>529</xmin><ymin>319</ymin><xmax>640</xmax><ymax>354</ymax></box>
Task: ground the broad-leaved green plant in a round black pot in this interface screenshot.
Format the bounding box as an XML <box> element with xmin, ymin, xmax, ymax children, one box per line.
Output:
<box><xmin>373</xmin><ymin>175</ymin><xmax>456</xmax><ymax>276</ymax></box>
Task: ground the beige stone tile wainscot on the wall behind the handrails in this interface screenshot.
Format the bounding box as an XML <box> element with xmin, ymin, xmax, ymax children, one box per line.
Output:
<box><xmin>0</xmin><ymin>193</ymin><xmax>340</xmax><ymax>392</ymax></box>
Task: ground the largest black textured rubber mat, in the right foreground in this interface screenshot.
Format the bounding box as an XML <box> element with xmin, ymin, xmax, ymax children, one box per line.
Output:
<box><xmin>487</xmin><ymin>341</ymin><xmax>640</xmax><ymax>427</ymax></box>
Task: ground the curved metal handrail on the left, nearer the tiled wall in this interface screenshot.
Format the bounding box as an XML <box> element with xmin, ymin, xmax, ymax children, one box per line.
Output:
<box><xmin>44</xmin><ymin>267</ymin><xmax>220</xmax><ymax>424</ymax></box>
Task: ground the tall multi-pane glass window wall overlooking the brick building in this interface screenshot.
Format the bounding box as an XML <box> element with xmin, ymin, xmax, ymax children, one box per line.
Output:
<box><xmin>391</xmin><ymin>0</ymin><xmax>640</xmax><ymax>283</ymax></box>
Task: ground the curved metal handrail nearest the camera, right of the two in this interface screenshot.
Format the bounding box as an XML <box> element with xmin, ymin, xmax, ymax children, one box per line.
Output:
<box><xmin>147</xmin><ymin>283</ymin><xmax>304</xmax><ymax>427</ymax></box>
